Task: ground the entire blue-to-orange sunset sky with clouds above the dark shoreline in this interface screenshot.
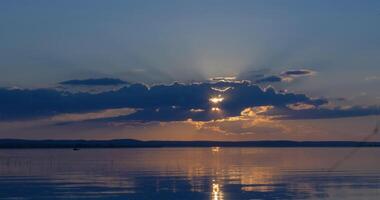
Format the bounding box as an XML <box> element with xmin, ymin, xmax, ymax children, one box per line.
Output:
<box><xmin>0</xmin><ymin>0</ymin><xmax>380</xmax><ymax>141</ymax></box>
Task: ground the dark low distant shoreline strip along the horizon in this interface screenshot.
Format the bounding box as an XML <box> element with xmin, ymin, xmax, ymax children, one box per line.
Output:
<box><xmin>0</xmin><ymin>139</ymin><xmax>380</xmax><ymax>149</ymax></box>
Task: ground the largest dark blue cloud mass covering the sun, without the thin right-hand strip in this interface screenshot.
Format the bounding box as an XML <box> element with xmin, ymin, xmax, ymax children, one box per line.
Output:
<box><xmin>0</xmin><ymin>82</ymin><xmax>327</xmax><ymax>121</ymax></box>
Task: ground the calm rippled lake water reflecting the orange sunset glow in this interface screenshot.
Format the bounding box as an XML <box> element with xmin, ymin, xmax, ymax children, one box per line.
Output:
<box><xmin>0</xmin><ymin>148</ymin><xmax>380</xmax><ymax>200</ymax></box>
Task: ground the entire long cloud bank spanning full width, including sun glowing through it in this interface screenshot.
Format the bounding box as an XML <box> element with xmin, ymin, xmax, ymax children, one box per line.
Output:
<box><xmin>0</xmin><ymin>78</ymin><xmax>380</xmax><ymax>122</ymax></box>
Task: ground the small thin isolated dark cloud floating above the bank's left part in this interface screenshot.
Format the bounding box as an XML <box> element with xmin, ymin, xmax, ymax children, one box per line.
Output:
<box><xmin>59</xmin><ymin>78</ymin><xmax>128</xmax><ymax>86</ymax></box>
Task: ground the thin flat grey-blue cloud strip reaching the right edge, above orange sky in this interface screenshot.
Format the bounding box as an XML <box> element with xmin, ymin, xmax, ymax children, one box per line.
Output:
<box><xmin>265</xmin><ymin>106</ymin><xmax>380</xmax><ymax>120</ymax></box>
